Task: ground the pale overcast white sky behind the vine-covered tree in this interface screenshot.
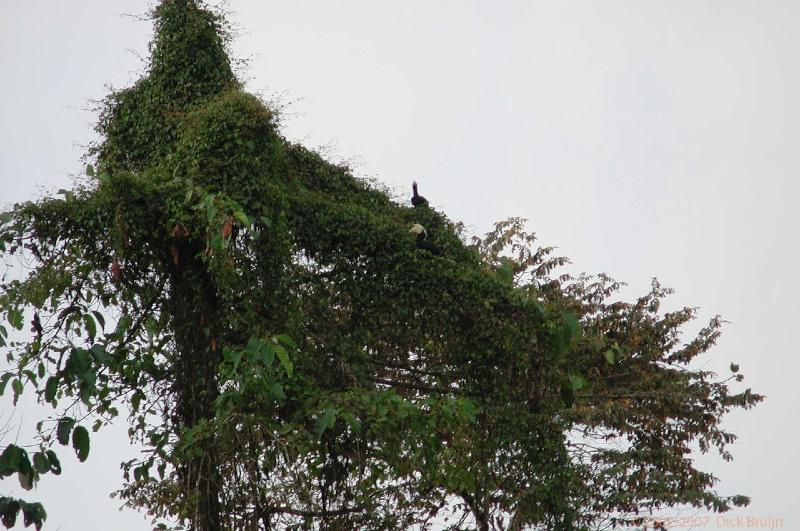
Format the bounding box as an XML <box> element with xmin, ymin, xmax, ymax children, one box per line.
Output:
<box><xmin>0</xmin><ymin>0</ymin><xmax>800</xmax><ymax>531</ymax></box>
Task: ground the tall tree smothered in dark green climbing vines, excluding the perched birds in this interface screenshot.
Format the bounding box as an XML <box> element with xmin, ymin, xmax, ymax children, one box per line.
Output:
<box><xmin>0</xmin><ymin>0</ymin><xmax>761</xmax><ymax>531</ymax></box>
